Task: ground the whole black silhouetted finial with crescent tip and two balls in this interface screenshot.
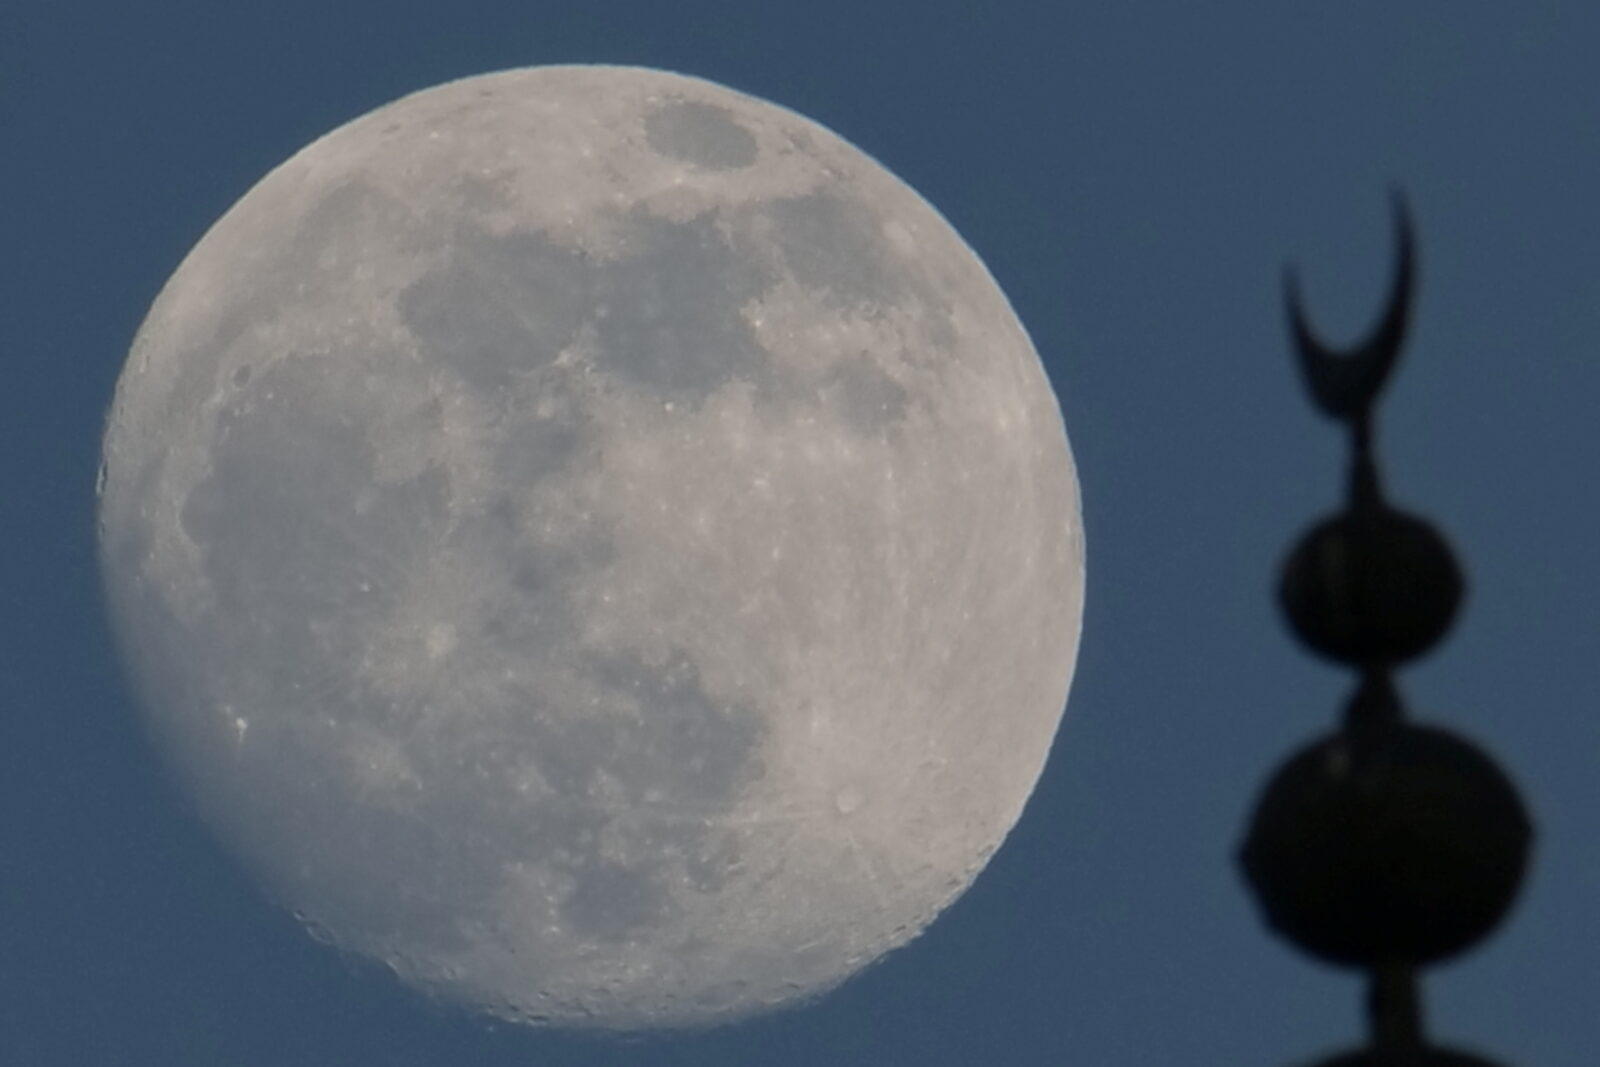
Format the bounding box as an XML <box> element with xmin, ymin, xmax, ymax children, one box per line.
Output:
<box><xmin>1240</xmin><ymin>192</ymin><xmax>1533</xmax><ymax>1067</ymax></box>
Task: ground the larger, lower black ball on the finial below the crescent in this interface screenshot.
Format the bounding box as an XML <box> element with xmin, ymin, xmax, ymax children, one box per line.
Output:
<box><xmin>1240</xmin><ymin>725</ymin><xmax>1533</xmax><ymax>966</ymax></box>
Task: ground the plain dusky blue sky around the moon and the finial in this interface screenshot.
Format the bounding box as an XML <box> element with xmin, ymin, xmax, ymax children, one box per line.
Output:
<box><xmin>0</xmin><ymin>0</ymin><xmax>1600</xmax><ymax>1067</ymax></box>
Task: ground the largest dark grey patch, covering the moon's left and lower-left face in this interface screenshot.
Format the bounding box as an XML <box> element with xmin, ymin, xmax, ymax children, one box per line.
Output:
<box><xmin>181</xmin><ymin>347</ymin><xmax>766</xmax><ymax>950</ymax></box>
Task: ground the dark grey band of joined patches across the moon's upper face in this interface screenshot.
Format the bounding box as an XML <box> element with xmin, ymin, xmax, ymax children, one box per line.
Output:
<box><xmin>400</xmin><ymin>194</ymin><xmax>942</xmax><ymax>441</ymax></box>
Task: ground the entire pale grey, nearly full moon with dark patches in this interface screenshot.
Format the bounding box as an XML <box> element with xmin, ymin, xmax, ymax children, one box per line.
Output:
<box><xmin>99</xmin><ymin>66</ymin><xmax>1083</xmax><ymax>1029</ymax></box>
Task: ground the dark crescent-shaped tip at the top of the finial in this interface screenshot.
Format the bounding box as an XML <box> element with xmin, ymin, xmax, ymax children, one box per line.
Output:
<box><xmin>1283</xmin><ymin>187</ymin><xmax>1416</xmax><ymax>419</ymax></box>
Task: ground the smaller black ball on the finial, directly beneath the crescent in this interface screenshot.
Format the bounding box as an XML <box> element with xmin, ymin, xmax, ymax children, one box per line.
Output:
<box><xmin>1278</xmin><ymin>504</ymin><xmax>1462</xmax><ymax>665</ymax></box>
